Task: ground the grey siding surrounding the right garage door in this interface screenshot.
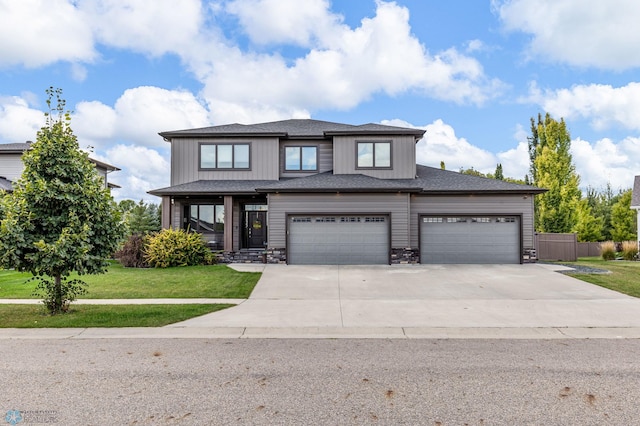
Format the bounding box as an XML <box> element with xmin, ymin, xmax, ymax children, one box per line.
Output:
<box><xmin>411</xmin><ymin>194</ymin><xmax>534</xmax><ymax>249</ymax></box>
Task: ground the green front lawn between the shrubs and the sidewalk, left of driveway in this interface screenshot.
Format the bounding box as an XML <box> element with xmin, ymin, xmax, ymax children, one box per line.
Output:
<box><xmin>0</xmin><ymin>262</ymin><xmax>261</xmax><ymax>299</ymax></box>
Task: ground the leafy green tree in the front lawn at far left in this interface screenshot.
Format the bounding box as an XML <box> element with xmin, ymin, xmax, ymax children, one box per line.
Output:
<box><xmin>0</xmin><ymin>88</ymin><xmax>123</xmax><ymax>314</ymax></box>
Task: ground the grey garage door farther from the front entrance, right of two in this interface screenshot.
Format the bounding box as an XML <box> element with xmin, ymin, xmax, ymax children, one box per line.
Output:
<box><xmin>420</xmin><ymin>216</ymin><xmax>521</xmax><ymax>263</ymax></box>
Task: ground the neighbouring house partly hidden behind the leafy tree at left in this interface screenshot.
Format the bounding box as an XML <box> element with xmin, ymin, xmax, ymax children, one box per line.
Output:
<box><xmin>0</xmin><ymin>142</ymin><xmax>120</xmax><ymax>191</ymax></box>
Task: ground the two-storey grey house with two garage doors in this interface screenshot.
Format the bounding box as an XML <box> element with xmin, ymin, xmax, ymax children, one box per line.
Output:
<box><xmin>149</xmin><ymin>120</ymin><xmax>544</xmax><ymax>264</ymax></box>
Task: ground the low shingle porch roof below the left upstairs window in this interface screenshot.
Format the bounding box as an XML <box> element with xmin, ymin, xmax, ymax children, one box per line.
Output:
<box><xmin>149</xmin><ymin>180</ymin><xmax>277</xmax><ymax>196</ymax></box>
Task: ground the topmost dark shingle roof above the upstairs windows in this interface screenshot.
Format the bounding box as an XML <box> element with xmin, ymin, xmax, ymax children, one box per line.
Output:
<box><xmin>160</xmin><ymin>119</ymin><xmax>425</xmax><ymax>139</ymax></box>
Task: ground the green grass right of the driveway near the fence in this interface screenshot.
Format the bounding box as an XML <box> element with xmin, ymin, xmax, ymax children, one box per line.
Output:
<box><xmin>562</xmin><ymin>257</ymin><xmax>640</xmax><ymax>297</ymax></box>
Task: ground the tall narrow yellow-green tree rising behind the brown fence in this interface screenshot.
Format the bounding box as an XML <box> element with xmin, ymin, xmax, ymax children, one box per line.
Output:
<box><xmin>530</xmin><ymin>114</ymin><xmax>581</xmax><ymax>232</ymax></box>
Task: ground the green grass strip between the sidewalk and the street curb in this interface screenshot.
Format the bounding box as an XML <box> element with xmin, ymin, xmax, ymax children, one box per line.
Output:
<box><xmin>0</xmin><ymin>304</ymin><xmax>233</xmax><ymax>328</ymax></box>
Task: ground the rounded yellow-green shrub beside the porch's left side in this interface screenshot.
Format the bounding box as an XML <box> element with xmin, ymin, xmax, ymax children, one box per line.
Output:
<box><xmin>146</xmin><ymin>229</ymin><xmax>210</xmax><ymax>268</ymax></box>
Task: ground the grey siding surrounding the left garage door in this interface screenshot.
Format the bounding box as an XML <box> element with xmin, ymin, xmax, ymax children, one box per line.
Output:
<box><xmin>268</xmin><ymin>193</ymin><xmax>409</xmax><ymax>248</ymax></box>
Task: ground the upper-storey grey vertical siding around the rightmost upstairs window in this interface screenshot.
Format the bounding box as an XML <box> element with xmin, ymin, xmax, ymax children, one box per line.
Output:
<box><xmin>333</xmin><ymin>136</ymin><xmax>416</xmax><ymax>179</ymax></box>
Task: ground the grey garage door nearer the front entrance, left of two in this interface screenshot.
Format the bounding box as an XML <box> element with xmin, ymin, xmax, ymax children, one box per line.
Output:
<box><xmin>287</xmin><ymin>215</ymin><xmax>389</xmax><ymax>265</ymax></box>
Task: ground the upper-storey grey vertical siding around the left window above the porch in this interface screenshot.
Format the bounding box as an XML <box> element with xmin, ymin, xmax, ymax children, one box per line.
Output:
<box><xmin>171</xmin><ymin>138</ymin><xmax>279</xmax><ymax>186</ymax></box>
